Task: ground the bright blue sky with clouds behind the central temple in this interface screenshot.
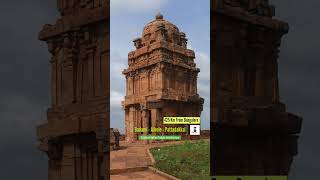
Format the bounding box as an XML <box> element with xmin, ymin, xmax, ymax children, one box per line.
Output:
<box><xmin>110</xmin><ymin>0</ymin><xmax>210</xmax><ymax>133</ymax></box>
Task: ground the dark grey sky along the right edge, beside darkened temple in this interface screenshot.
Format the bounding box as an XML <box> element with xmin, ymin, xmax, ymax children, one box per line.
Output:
<box><xmin>271</xmin><ymin>0</ymin><xmax>320</xmax><ymax>180</ymax></box>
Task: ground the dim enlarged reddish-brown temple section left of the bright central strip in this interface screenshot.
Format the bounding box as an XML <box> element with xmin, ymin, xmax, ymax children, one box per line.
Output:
<box><xmin>37</xmin><ymin>0</ymin><xmax>109</xmax><ymax>180</ymax></box>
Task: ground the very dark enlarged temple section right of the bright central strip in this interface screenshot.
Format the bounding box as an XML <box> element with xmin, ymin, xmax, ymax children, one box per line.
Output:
<box><xmin>211</xmin><ymin>0</ymin><xmax>302</xmax><ymax>175</ymax></box>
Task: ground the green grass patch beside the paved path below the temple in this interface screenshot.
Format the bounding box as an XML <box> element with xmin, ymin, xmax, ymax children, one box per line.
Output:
<box><xmin>150</xmin><ymin>140</ymin><xmax>210</xmax><ymax>180</ymax></box>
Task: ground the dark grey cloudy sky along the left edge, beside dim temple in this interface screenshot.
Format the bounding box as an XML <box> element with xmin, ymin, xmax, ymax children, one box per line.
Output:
<box><xmin>0</xmin><ymin>0</ymin><xmax>57</xmax><ymax>180</ymax></box>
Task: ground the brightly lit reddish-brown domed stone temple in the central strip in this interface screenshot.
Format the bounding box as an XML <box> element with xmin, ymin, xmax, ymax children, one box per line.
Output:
<box><xmin>122</xmin><ymin>13</ymin><xmax>204</xmax><ymax>142</ymax></box>
